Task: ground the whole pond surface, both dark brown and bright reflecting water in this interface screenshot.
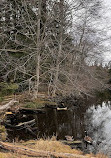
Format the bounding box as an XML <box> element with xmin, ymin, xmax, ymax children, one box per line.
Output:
<box><xmin>8</xmin><ymin>101</ymin><xmax>111</xmax><ymax>155</ymax></box>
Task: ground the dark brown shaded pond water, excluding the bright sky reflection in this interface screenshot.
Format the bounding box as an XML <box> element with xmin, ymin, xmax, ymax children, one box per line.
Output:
<box><xmin>8</xmin><ymin>107</ymin><xmax>86</xmax><ymax>140</ymax></box>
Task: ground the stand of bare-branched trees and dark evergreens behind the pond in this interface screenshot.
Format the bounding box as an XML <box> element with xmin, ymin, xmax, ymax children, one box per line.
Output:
<box><xmin>0</xmin><ymin>0</ymin><xmax>106</xmax><ymax>97</ymax></box>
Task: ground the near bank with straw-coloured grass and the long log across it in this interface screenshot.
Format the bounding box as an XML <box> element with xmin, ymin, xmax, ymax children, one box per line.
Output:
<box><xmin>0</xmin><ymin>137</ymin><xmax>108</xmax><ymax>158</ymax></box>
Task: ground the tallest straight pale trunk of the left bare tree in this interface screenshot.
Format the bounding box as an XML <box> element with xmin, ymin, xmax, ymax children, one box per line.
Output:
<box><xmin>35</xmin><ymin>0</ymin><xmax>47</xmax><ymax>98</ymax></box>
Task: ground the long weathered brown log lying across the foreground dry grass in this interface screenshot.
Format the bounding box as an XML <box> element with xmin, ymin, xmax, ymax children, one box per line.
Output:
<box><xmin>0</xmin><ymin>142</ymin><xmax>94</xmax><ymax>158</ymax></box>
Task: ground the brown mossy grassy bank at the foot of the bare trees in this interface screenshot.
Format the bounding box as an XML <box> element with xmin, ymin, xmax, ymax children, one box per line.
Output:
<box><xmin>0</xmin><ymin>92</ymin><xmax>57</xmax><ymax>109</ymax></box>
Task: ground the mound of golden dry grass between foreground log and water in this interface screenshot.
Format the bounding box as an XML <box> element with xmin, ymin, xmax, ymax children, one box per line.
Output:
<box><xmin>22</xmin><ymin>137</ymin><xmax>108</xmax><ymax>158</ymax></box>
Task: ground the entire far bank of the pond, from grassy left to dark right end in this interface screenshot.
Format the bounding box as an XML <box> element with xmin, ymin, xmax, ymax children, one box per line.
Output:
<box><xmin>0</xmin><ymin>91</ymin><xmax>111</xmax><ymax>109</ymax></box>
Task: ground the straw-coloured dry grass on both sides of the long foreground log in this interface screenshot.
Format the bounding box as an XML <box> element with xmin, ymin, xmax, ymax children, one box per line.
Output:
<box><xmin>0</xmin><ymin>138</ymin><xmax>108</xmax><ymax>158</ymax></box>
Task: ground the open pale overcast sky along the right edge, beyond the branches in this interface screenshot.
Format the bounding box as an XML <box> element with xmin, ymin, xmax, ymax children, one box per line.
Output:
<box><xmin>71</xmin><ymin>0</ymin><xmax>111</xmax><ymax>65</ymax></box>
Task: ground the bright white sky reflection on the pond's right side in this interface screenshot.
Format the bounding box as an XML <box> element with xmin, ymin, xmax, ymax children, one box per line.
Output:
<box><xmin>86</xmin><ymin>101</ymin><xmax>111</xmax><ymax>155</ymax></box>
